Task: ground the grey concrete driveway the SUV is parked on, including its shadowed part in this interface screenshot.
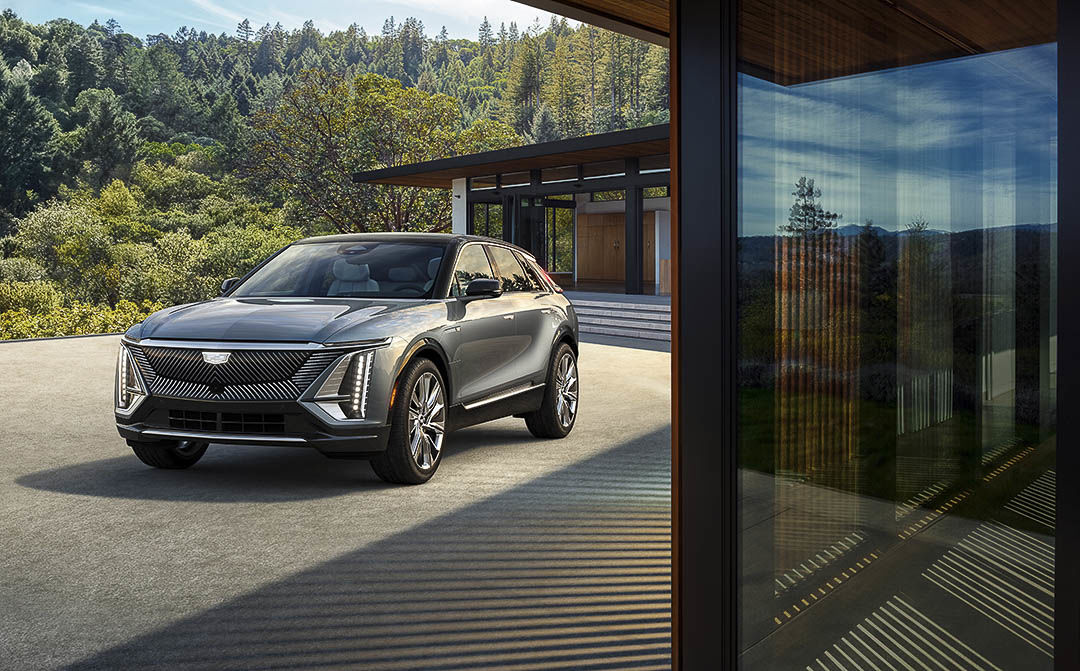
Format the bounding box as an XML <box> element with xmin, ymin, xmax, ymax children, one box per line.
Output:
<box><xmin>0</xmin><ymin>337</ymin><xmax>671</xmax><ymax>669</ymax></box>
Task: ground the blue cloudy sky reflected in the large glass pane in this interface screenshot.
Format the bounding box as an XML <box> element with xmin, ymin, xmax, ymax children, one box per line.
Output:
<box><xmin>739</xmin><ymin>44</ymin><xmax>1057</xmax><ymax>236</ymax></box>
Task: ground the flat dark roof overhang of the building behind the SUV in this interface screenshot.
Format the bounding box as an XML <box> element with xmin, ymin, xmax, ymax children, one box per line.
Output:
<box><xmin>352</xmin><ymin>124</ymin><xmax>671</xmax><ymax>189</ymax></box>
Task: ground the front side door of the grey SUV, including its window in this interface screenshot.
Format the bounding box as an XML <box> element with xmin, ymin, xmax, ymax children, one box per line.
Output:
<box><xmin>446</xmin><ymin>242</ymin><xmax>519</xmax><ymax>402</ymax></box>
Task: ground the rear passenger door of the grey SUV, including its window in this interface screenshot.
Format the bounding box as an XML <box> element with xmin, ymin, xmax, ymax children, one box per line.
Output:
<box><xmin>488</xmin><ymin>245</ymin><xmax>553</xmax><ymax>384</ymax></box>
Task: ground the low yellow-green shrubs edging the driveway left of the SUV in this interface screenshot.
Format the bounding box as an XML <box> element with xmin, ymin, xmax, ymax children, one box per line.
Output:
<box><xmin>0</xmin><ymin>300</ymin><xmax>163</xmax><ymax>339</ymax></box>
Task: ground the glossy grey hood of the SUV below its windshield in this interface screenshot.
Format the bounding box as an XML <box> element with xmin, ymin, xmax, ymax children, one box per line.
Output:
<box><xmin>137</xmin><ymin>298</ymin><xmax>431</xmax><ymax>343</ymax></box>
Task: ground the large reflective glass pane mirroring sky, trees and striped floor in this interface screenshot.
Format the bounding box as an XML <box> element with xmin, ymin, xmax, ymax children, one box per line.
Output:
<box><xmin>739</xmin><ymin>0</ymin><xmax>1057</xmax><ymax>670</ymax></box>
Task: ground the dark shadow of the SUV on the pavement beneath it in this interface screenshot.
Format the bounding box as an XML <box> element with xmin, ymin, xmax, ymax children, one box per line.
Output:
<box><xmin>15</xmin><ymin>427</ymin><xmax>548</xmax><ymax>502</ymax></box>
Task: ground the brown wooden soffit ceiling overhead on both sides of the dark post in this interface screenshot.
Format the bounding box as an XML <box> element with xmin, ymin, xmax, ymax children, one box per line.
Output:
<box><xmin>518</xmin><ymin>0</ymin><xmax>1057</xmax><ymax>85</ymax></box>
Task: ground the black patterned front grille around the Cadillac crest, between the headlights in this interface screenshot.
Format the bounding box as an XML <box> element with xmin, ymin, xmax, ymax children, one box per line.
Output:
<box><xmin>129</xmin><ymin>345</ymin><xmax>341</xmax><ymax>401</ymax></box>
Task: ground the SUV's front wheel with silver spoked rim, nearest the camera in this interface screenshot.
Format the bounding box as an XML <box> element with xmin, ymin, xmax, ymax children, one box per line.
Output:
<box><xmin>372</xmin><ymin>357</ymin><xmax>447</xmax><ymax>484</ymax></box>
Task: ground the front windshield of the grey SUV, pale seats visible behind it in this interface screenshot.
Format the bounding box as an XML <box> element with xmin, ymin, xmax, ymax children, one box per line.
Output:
<box><xmin>230</xmin><ymin>241</ymin><xmax>446</xmax><ymax>298</ymax></box>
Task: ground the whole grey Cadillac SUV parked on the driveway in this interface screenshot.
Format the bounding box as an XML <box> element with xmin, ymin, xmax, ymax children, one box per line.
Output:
<box><xmin>116</xmin><ymin>233</ymin><xmax>580</xmax><ymax>483</ymax></box>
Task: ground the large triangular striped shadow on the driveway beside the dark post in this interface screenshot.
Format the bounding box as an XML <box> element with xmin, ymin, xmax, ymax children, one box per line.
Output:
<box><xmin>63</xmin><ymin>428</ymin><xmax>671</xmax><ymax>671</ymax></box>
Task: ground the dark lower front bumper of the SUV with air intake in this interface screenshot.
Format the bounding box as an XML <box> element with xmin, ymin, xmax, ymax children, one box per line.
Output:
<box><xmin>114</xmin><ymin>397</ymin><xmax>390</xmax><ymax>459</ymax></box>
